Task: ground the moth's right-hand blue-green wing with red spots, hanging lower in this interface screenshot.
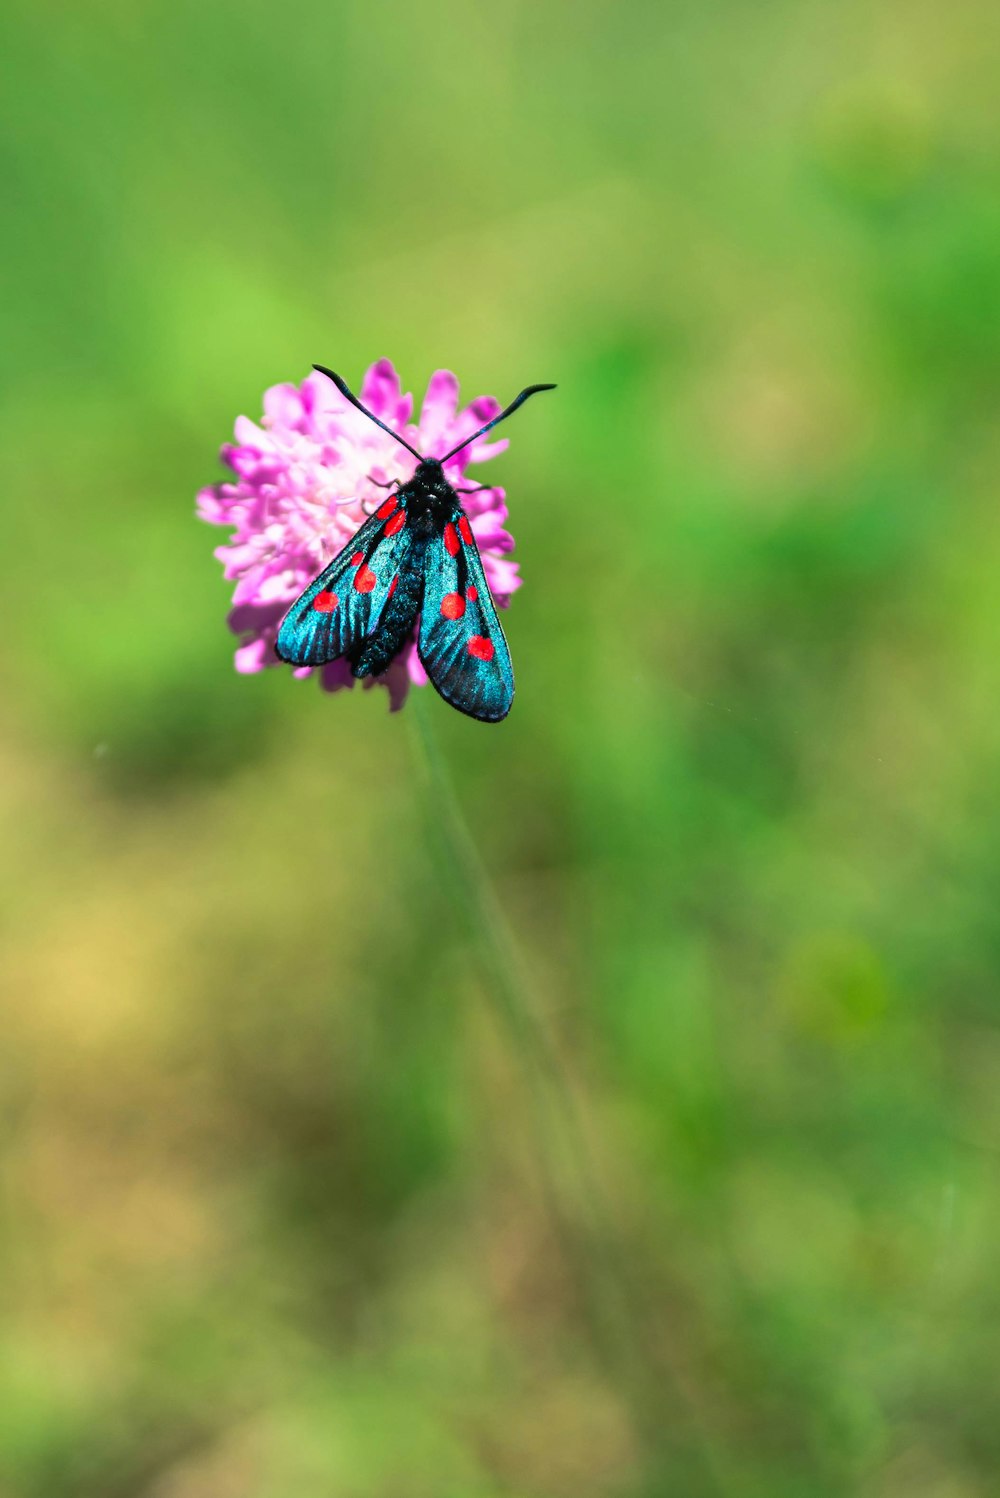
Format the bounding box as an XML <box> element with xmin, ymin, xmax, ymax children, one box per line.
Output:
<box><xmin>418</xmin><ymin>508</ymin><xmax>513</xmax><ymax>724</ymax></box>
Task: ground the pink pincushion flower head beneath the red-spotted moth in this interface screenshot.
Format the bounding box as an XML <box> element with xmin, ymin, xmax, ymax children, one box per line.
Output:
<box><xmin>198</xmin><ymin>360</ymin><xmax>521</xmax><ymax>709</ymax></box>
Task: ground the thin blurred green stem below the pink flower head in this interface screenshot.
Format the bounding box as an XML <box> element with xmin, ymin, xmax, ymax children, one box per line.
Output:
<box><xmin>407</xmin><ymin>691</ymin><xmax>735</xmax><ymax>1498</ymax></box>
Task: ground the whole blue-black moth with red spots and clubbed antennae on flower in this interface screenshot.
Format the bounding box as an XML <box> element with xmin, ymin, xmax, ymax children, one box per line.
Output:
<box><xmin>275</xmin><ymin>364</ymin><xmax>555</xmax><ymax>724</ymax></box>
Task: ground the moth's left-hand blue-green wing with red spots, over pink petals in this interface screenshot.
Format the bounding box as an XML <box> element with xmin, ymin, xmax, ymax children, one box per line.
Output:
<box><xmin>274</xmin><ymin>494</ymin><xmax>412</xmax><ymax>665</ymax></box>
